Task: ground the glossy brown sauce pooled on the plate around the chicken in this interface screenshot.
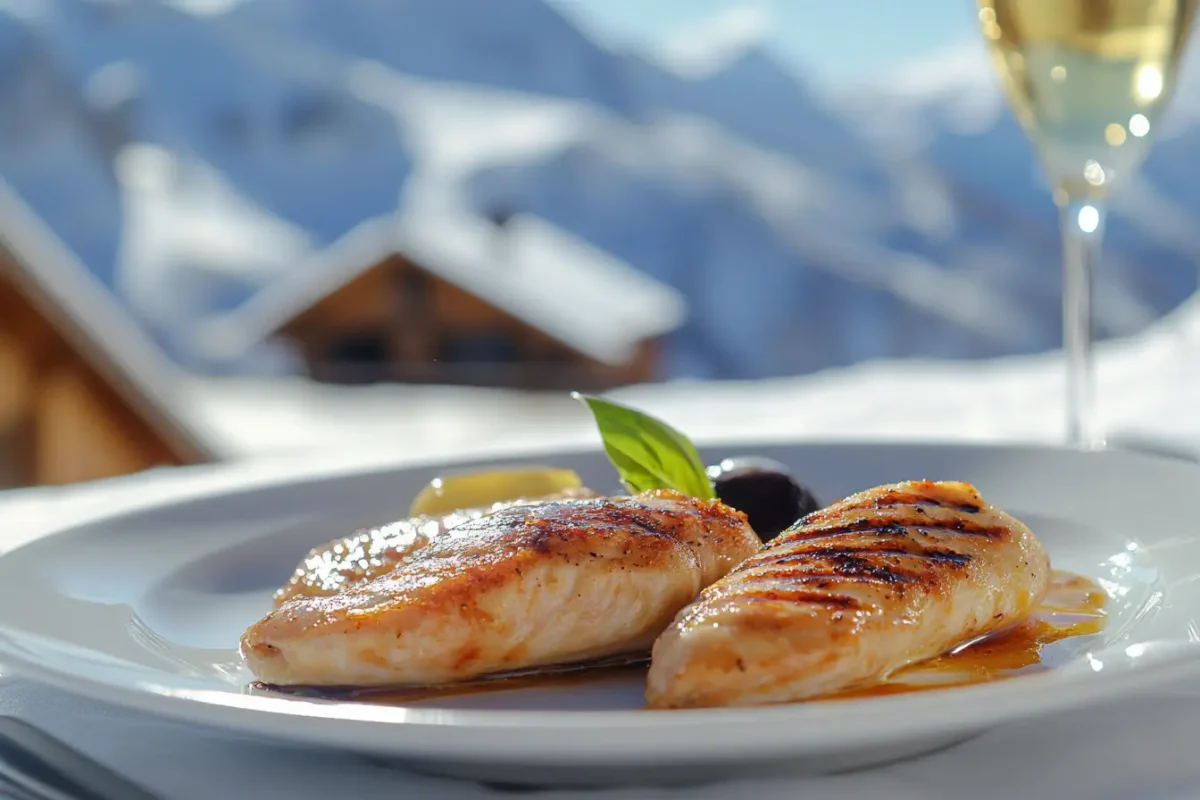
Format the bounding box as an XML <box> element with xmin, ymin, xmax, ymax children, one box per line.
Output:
<box><xmin>251</xmin><ymin>571</ymin><xmax>1106</xmax><ymax>705</ymax></box>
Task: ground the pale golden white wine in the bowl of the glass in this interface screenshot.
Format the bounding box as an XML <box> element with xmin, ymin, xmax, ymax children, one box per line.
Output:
<box><xmin>979</xmin><ymin>0</ymin><xmax>1196</xmax><ymax>203</ymax></box>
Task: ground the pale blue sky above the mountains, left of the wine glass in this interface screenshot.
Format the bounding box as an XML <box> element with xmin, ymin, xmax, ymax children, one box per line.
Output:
<box><xmin>554</xmin><ymin>0</ymin><xmax>978</xmax><ymax>79</ymax></box>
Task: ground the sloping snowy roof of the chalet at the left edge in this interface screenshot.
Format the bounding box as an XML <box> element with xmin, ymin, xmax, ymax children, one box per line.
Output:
<box><xmin>0</xmin><ymin>180</ymin><xmax>220</xmax><ymax>461</ymax></box>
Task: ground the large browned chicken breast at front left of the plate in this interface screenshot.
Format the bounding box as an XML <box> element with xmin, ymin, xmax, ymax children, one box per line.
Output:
<box><xmin>242</xmin><ymin>492</ymin><xmax>761</xmax><ymax>686</ymax></box>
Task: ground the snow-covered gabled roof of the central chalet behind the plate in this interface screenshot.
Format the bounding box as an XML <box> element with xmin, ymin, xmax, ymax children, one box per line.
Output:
<box><xmin>200</xmin><ymin>204</ymin><xmax>686</xmax><ymax>365</ymax></box>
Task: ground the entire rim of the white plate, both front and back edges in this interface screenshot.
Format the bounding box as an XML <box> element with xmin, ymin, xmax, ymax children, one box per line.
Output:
<box><xmin>0</xmin><ymin>437</ymin><xmax>1200</xmax><ymax>760</ymax></box>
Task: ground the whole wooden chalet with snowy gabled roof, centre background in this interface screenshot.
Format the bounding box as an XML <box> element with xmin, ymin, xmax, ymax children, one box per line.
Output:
<box><xmin>196</xmin><ymin>210</ymin><xmax>684</xmax><ymax>390</ymax></box>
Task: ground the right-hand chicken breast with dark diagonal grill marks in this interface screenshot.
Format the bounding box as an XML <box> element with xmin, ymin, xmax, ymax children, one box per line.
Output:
<box><xmin>647</xmin><ymin>481</ymin><xmax>1050</xmax><ymax>708</ymax></box>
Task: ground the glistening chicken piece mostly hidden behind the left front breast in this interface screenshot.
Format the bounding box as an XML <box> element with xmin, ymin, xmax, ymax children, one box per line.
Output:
<box><xmin>275</xmin><ymin>488</ymin><xmax>596</xmax><ymax>607</ymax></box>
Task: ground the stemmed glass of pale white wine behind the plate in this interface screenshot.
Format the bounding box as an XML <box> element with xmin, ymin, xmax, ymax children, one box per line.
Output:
<box><xmin>978</xmin><ymin>0</ymin><xmax>1198</xmax><ymax>449</ymax></box>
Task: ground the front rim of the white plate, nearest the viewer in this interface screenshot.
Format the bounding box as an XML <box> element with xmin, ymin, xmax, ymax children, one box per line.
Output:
<box><xmin>6</xmin><ymin>650</ymin><xmax>1198</xmax><ymax>764</ymax></box>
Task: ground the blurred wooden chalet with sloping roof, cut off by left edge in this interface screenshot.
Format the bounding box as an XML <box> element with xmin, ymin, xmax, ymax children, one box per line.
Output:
<box><xmin>0</xmin><ymin>191</ymin><xmax>215</xmax><ymax>488</ymax></box>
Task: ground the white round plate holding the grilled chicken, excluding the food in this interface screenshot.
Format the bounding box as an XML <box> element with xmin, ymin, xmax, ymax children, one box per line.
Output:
<box><xmin>0</xmin><ymin>444</ymin><xmax>1200</xmax><ymax>783</ymax></box>
